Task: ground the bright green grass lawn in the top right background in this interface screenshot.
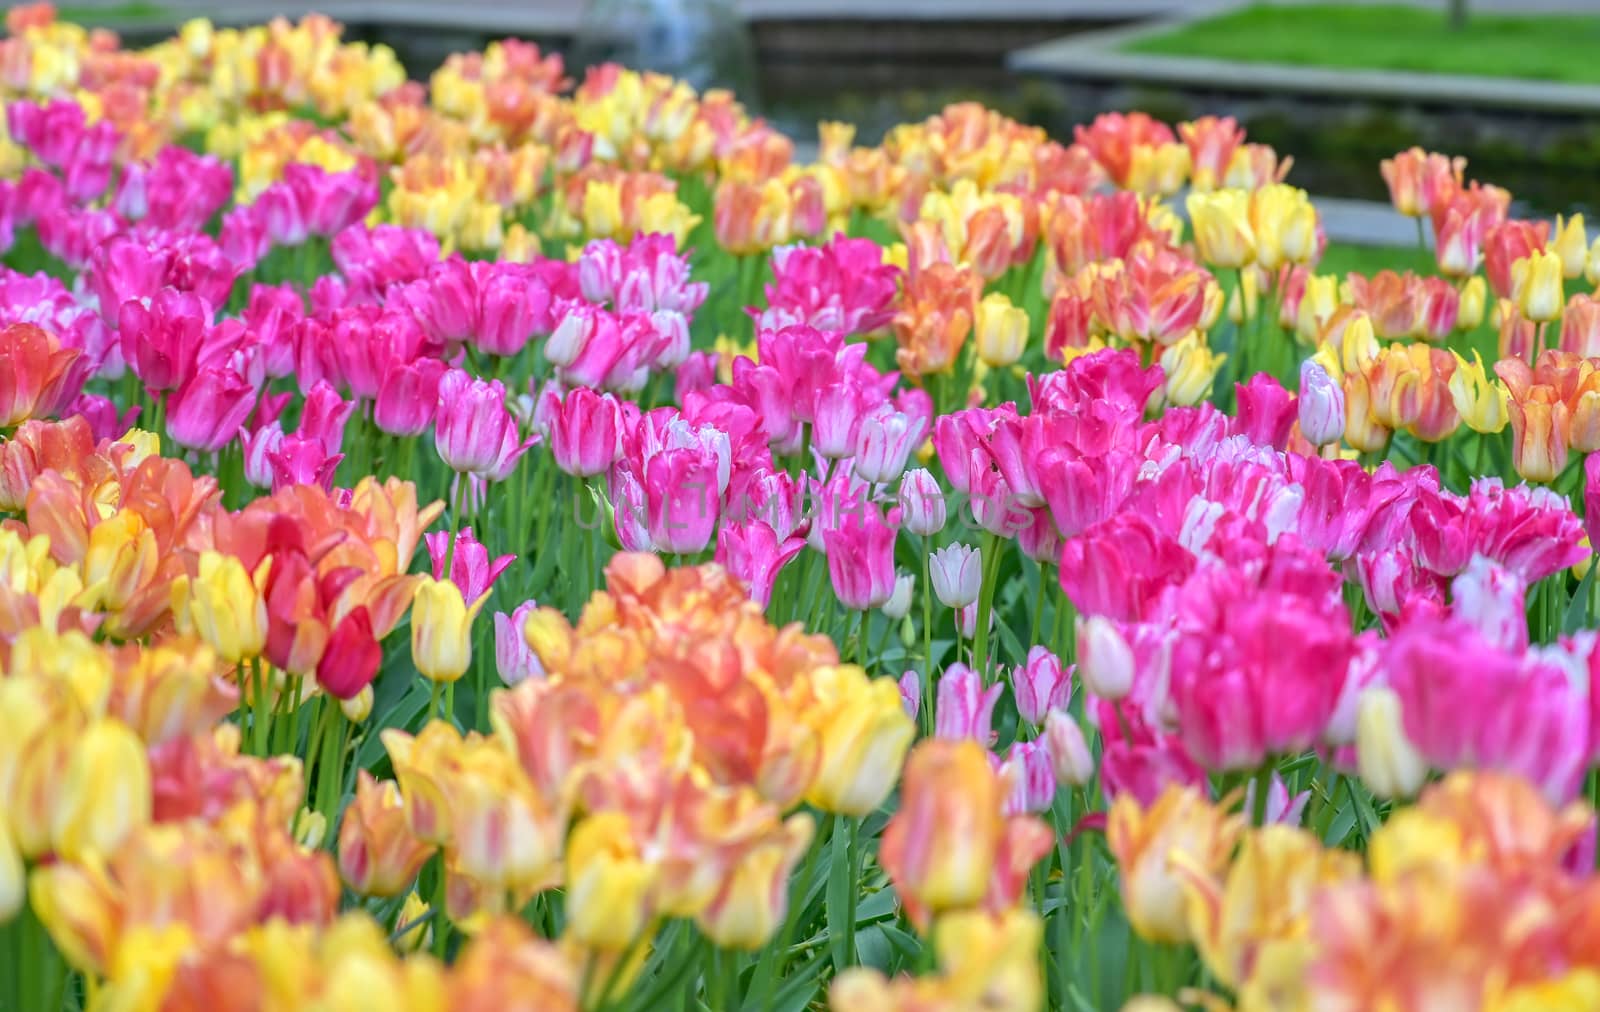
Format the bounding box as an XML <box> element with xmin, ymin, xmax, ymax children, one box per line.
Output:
<box><xmin>1128</xmin><ymin>0</ymin><xmax>1600</xmax><ymax>83</ymax></box>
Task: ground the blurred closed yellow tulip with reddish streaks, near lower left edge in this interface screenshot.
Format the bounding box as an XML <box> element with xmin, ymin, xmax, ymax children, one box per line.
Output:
<box><xmin>51</xmin><ymin>717</ymin><xmax>150</xmax><ymax>861</ymax></box>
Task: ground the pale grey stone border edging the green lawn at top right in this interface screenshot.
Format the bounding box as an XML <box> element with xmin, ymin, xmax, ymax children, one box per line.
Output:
<box><xmin>1006</xmin><ymin>3</ymin><xmax>1600</xmax><ymax>115</ymax></box>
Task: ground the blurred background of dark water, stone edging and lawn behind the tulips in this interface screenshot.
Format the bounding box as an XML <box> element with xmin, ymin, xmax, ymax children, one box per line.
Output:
<box><xmin>46</xmin><ymin>0</ymin><xmax>1600</xmax><ymax>213</ymax></box>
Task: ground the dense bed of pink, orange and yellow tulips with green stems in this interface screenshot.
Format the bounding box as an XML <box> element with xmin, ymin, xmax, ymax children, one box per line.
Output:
<box><xmin>0</xmin><ymin>6</ymin><xmax>1600</xmax><ymax>1012</ymax></box>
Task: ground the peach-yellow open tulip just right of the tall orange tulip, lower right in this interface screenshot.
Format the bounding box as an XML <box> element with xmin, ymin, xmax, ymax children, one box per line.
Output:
<box><xmin>1106</xmin><ymin>785</ymin><xmax>1243</xmax><ymax>943</ymax></box>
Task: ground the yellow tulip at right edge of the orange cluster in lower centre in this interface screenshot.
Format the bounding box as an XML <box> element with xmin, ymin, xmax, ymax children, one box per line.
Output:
<box><xmin>805</xmin><ymin>666</ymin><xmax>917</xmax><ymax>817</ymax></box>
